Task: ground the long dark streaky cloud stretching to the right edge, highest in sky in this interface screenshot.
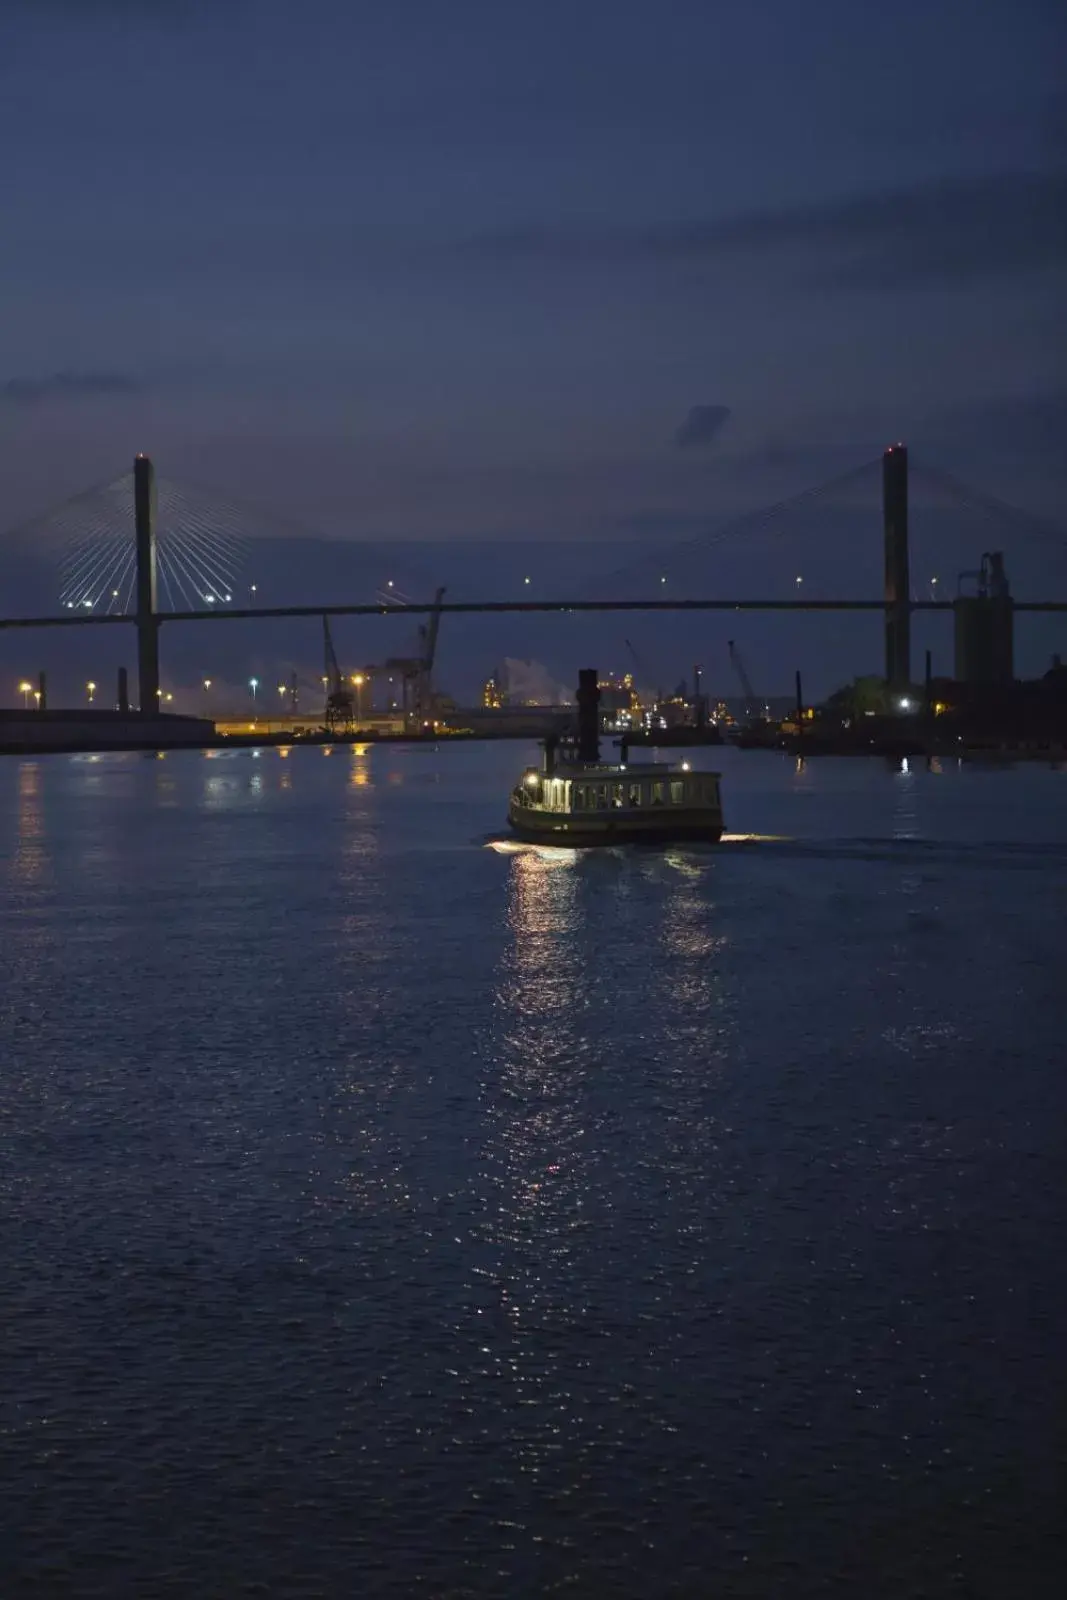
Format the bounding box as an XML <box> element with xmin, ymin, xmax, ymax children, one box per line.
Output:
<box><xmin>474</xmin><ymin>171</ymin><xmax>1067</xmax><ymax>288</ymax></box>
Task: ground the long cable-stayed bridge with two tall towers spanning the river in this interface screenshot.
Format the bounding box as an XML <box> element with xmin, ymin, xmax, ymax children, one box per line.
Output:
<box><xmin>0</xmin><ymin>445</ymin><xmax>1067</xmax><ymax>707</ymax></box>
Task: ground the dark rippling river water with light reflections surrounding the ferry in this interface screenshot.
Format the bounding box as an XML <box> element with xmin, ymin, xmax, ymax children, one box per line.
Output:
<box><xmin>0</xmin><ymin>746</ymin><xmax>1067</xmax><ymax>1600</ymax></box>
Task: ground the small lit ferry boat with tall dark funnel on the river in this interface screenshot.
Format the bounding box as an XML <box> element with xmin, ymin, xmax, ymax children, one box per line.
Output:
<box><xmin>507</xmin><ymin>667</ymin><xmax>723</xmax><ymax>845</ymax></box>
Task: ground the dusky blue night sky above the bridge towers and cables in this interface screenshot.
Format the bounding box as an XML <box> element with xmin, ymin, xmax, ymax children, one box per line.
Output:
<box><xmin>0</xmin><ymin>0</ymin><xmax>1067</xmax><ymax>694</ymax></box>
